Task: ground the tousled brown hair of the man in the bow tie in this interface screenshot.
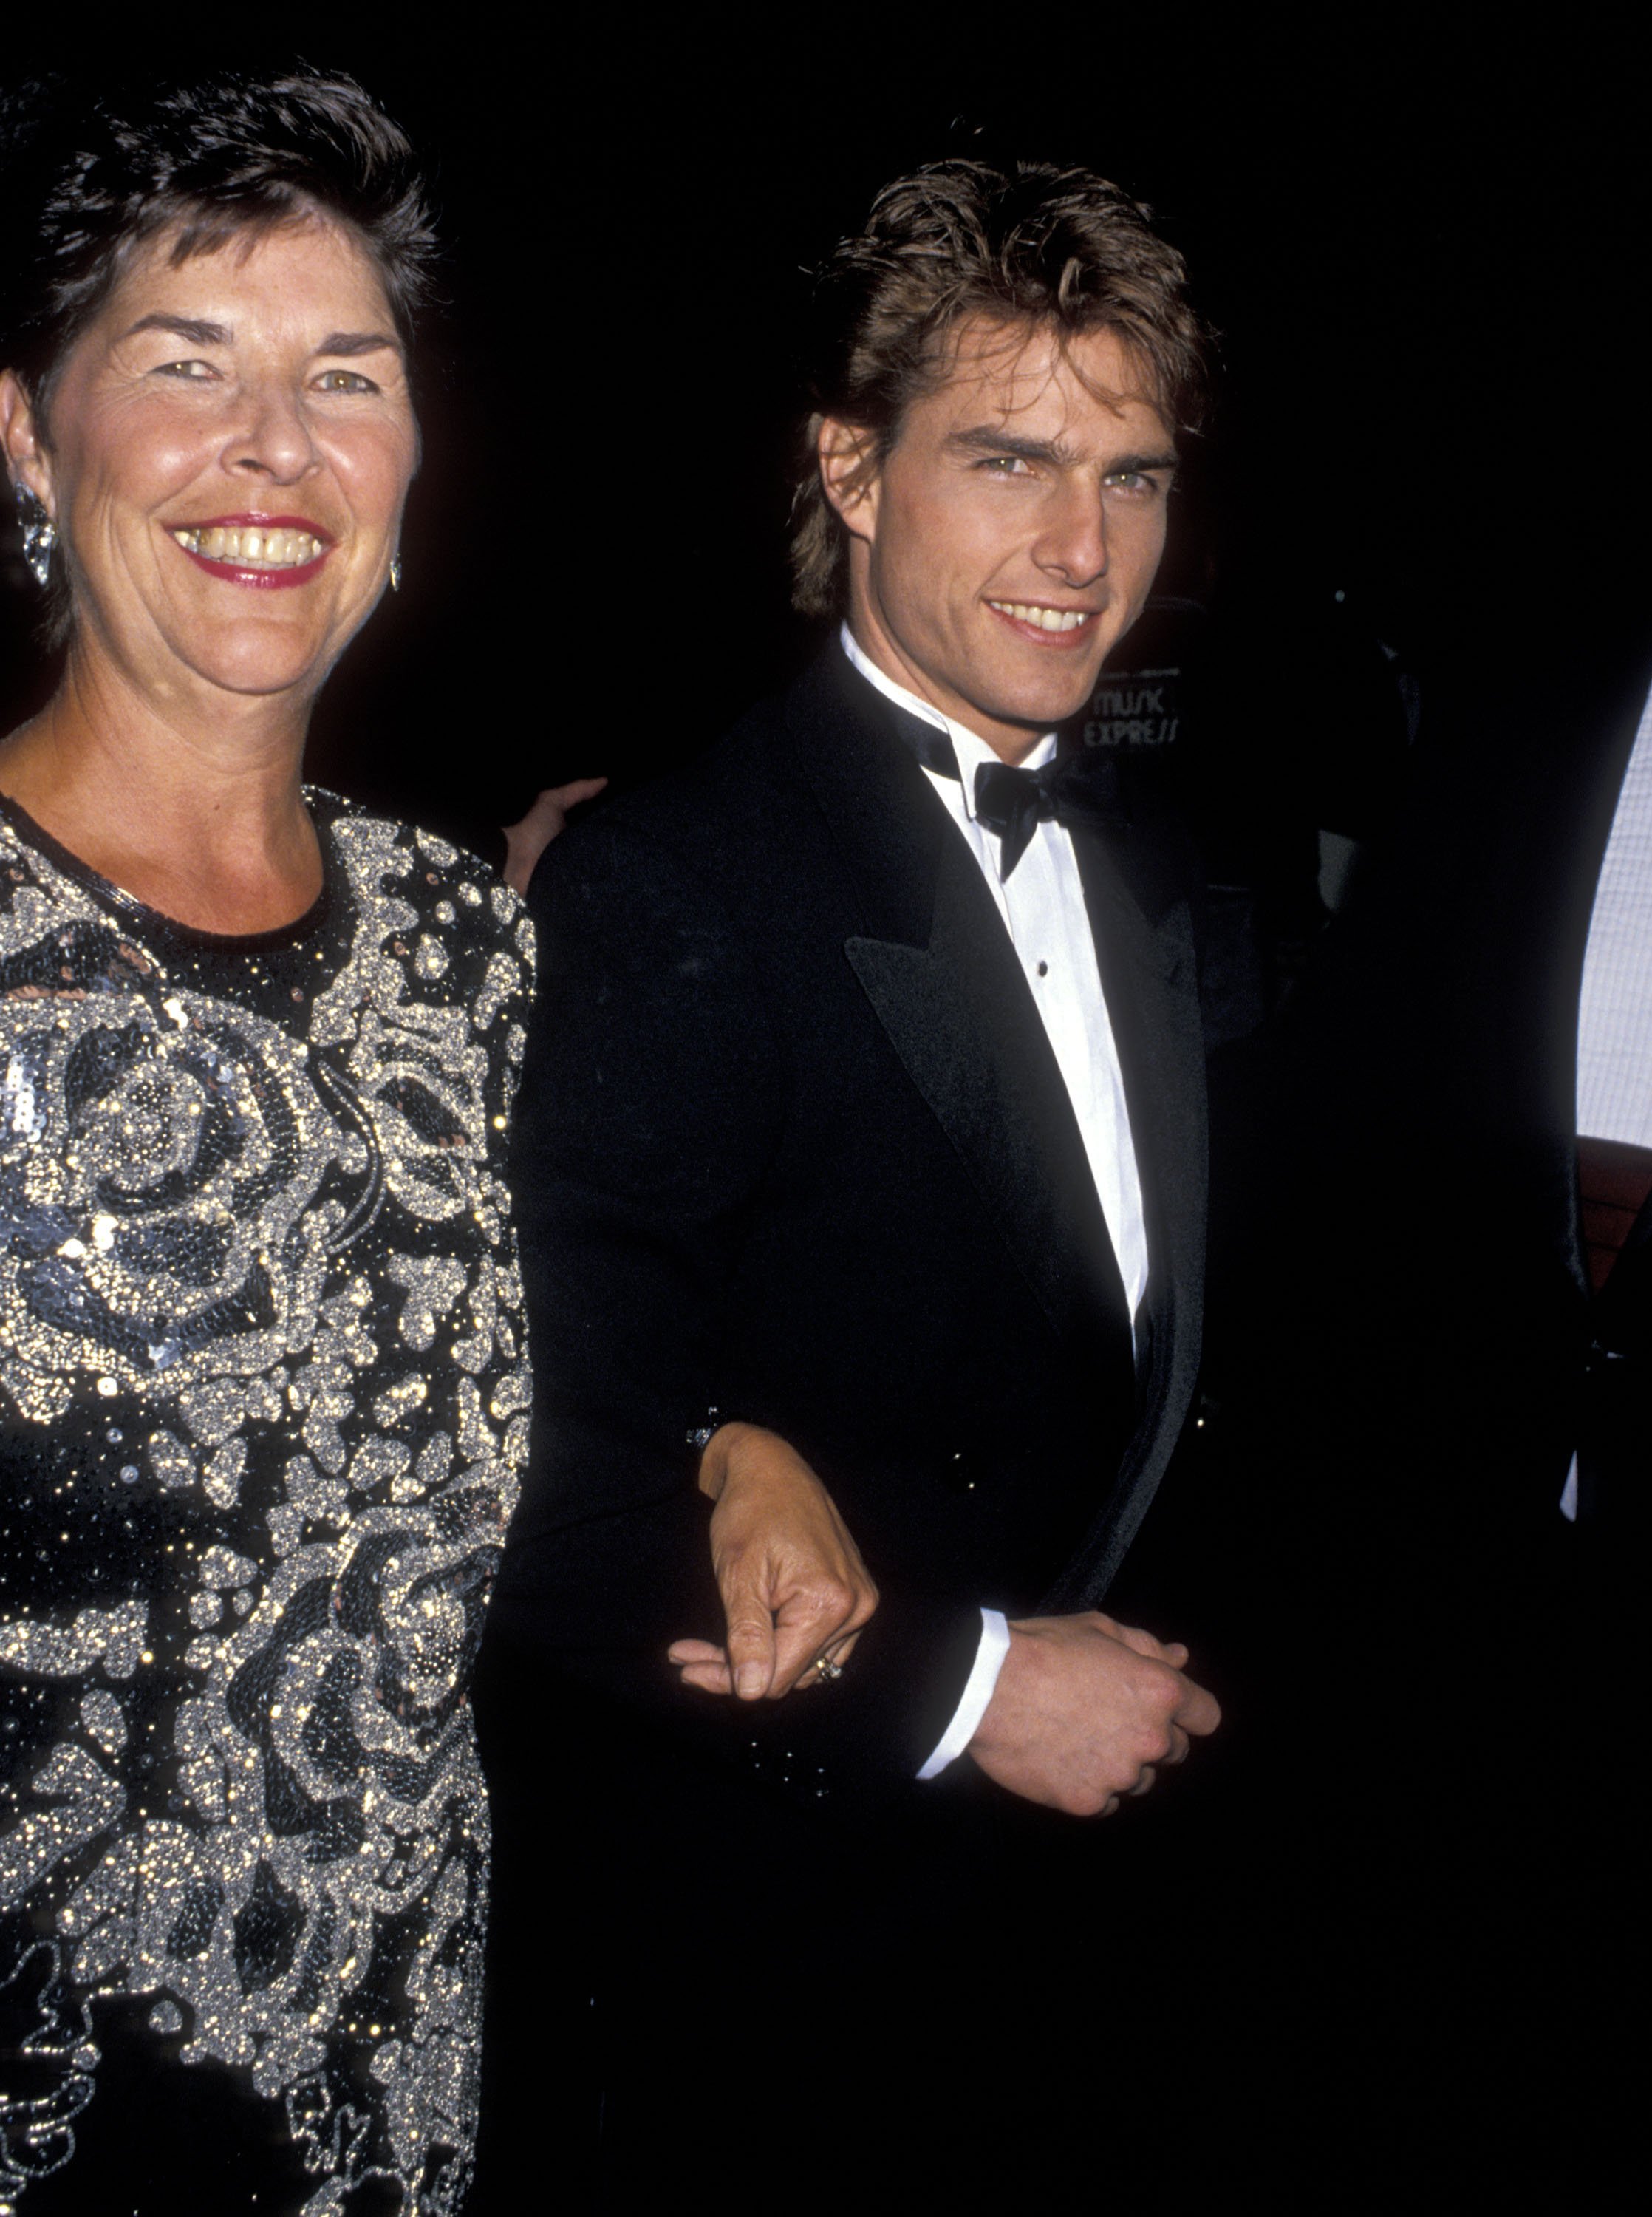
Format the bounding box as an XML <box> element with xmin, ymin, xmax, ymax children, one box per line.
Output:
<box><xmin>791</xmin><ymin>160</ymin><xmax>1209</xmax><ymax>616</ymax></box>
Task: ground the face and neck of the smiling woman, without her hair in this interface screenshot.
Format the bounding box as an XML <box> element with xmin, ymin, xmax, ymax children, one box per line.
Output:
<box><xmin>12</xmin><ymin>202</ymin><xmax>417</xmax><ymax>811</ymax></box>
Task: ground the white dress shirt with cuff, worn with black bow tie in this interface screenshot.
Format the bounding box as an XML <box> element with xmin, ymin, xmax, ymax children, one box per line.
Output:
<box><xmin>841</xmin><ymin>623</ymin><xmax>1149</xmax><ymax>1778</ymax></box>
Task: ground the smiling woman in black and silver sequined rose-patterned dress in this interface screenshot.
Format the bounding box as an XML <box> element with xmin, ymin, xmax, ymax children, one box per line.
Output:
<box><xmin>0</xmin><ymin>73</ymin><xmax>870</xmax><ymax>2217</ymax></box>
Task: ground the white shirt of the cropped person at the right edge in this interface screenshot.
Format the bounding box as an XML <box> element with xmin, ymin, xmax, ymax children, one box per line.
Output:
<box><xmin>1561</xmin><ymin>665</ymin><xmax>1652</xmax><ymax>1519</ymax></box>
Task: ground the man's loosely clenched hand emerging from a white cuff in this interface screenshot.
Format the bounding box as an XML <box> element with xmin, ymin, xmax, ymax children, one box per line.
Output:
<box><xmin>969</xmin><ymin>1612</ymin><xmax>1222</xmax><ymax>1816</ymax></box>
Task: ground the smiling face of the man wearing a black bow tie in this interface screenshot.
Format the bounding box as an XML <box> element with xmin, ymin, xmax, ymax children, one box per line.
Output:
<box><xmin>820</xmin><ymin>321</ymin><xmax>1175</xmax><ymax>760</ymax></box>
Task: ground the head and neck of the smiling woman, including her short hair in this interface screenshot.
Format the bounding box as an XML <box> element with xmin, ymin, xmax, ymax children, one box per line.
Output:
<box><xmin>0</xmin><ymin>98</ymin><xmax>430</xmax><ymax>931</ymax></box>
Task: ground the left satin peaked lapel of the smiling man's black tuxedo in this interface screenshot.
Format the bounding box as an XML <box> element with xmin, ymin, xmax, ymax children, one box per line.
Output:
<box><xmin>793</xmin><ymin>654</ymin><xmax>1129</xmax><ymax>1361</ymax></box>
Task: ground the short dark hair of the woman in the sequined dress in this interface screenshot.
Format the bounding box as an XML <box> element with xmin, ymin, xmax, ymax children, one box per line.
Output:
<box><xmin>0</xmin><ymin>69</ymin><xmax>437</xmax><ymax>643</ymax></box>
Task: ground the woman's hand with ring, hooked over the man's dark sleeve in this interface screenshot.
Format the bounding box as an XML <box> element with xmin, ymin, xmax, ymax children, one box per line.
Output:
<box><xmin>669</xmin><ymin>1423</ymin><xmax>878</xmax><ymax>1700</ymax></box>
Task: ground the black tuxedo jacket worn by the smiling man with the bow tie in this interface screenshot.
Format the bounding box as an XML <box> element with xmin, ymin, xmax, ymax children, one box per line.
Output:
<box><xmin>494</xmin><ymin>645</ymin><xmax>1206</xmax><ymax>1794</ymax></box>
